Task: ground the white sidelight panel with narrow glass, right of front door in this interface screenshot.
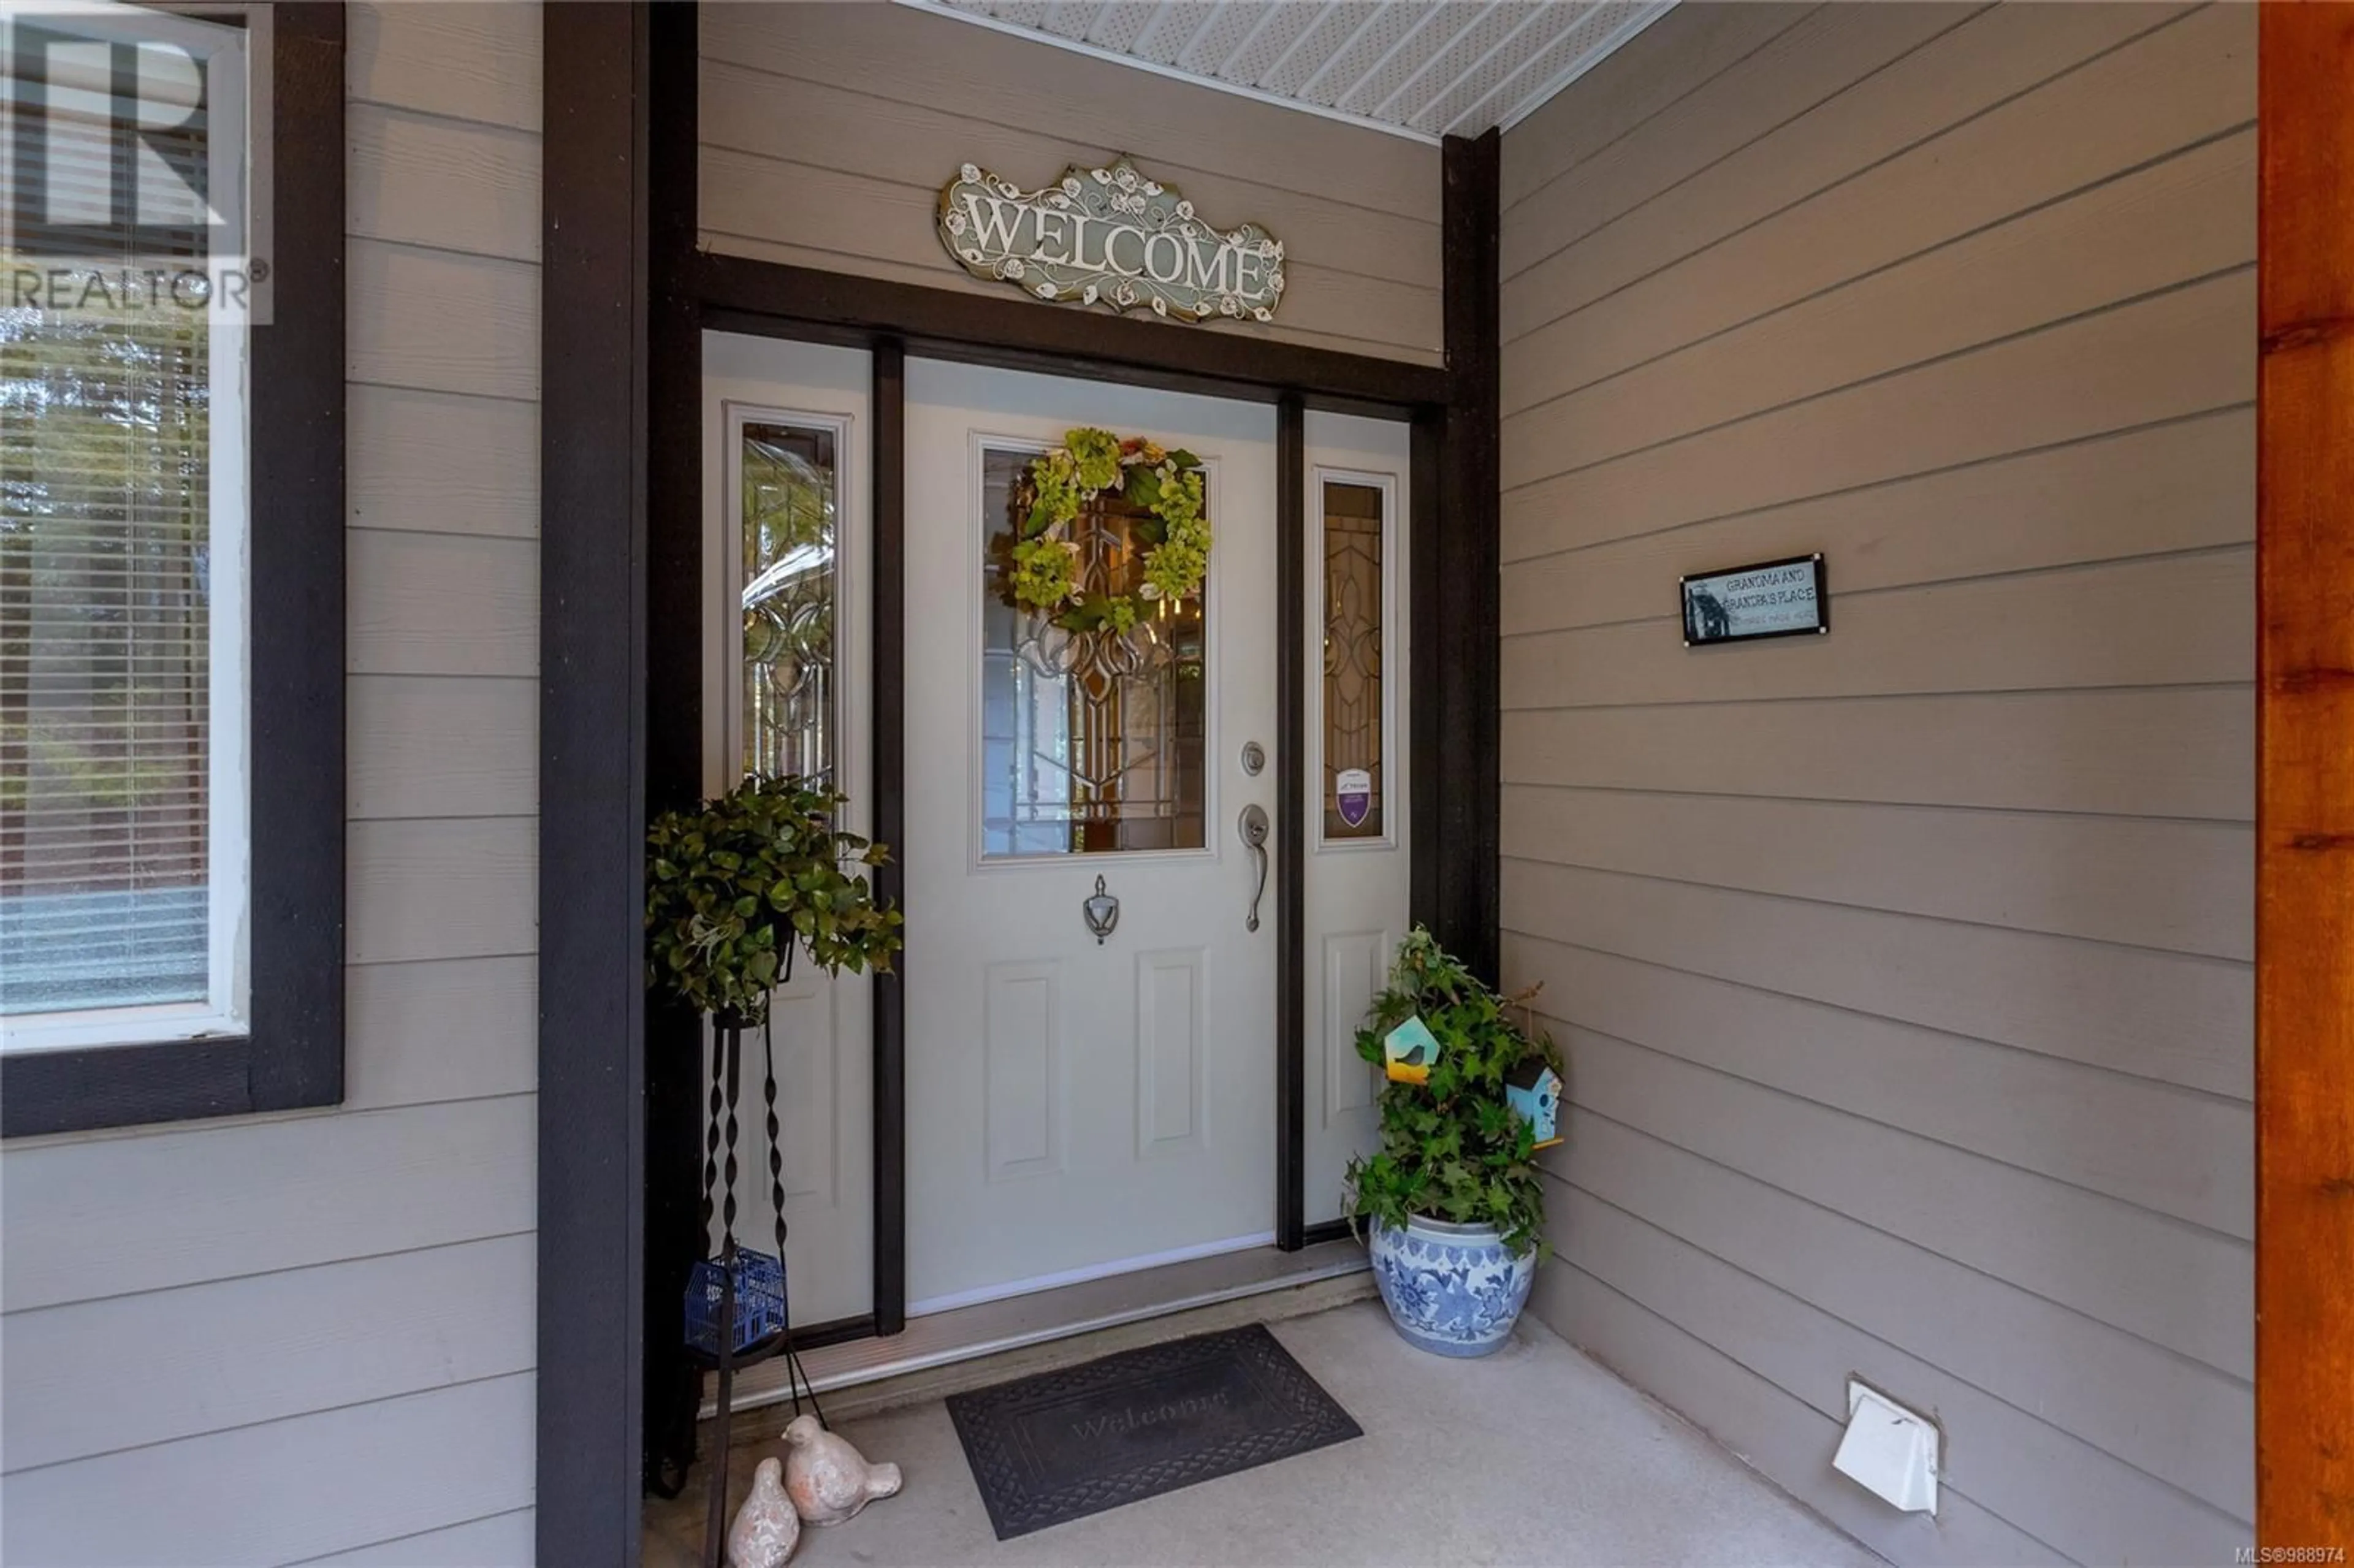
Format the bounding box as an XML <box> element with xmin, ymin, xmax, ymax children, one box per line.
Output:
<box><xmin>1302</xmin><ymin>412</ymin><xmax>1412</xmax><ymax>1224</ymax></box>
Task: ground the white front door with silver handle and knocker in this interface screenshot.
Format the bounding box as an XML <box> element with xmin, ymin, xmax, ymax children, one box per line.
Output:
<box><xmin>897</xmin><ymin>360</ymin><xmax>1278</xmax><ymax>1314</ymax></box>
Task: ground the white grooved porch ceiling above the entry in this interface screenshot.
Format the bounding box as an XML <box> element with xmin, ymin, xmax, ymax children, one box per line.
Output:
<box><xmin>899</xmin><ymin>0</ymin><xmax>1674</xmax><ymax>141</ymax></box>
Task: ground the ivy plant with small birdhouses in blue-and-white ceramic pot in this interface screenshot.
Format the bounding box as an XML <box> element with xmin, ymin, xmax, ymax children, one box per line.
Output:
<box><xmin>1346</xmin><ymin>925</ymin><xmax>1561</xmax><ymax>1356</ymax></box>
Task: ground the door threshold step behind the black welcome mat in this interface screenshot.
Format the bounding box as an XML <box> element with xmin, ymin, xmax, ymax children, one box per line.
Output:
<box><xmin>701</xmin><ymin>1236</ymin><xmax>1373</xmax><ymax>1420</ymax></box>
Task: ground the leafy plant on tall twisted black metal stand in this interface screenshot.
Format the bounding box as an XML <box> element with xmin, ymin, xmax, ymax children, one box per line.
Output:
<box><xmin>645</xmin><ymin>775</ymin><xmax>902</xmax><ymax>1568</ymax></box>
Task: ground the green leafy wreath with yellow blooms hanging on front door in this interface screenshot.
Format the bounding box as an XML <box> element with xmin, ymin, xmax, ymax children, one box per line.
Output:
<box><xmin>996</xmin><ymin>426</ymin><xmax>1210</xmax><ymax>631</ymax></box>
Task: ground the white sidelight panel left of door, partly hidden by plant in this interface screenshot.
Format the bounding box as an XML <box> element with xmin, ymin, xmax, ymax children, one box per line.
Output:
<box><xmin>704</xmin><ymin>332</ymin><xmax>874</xmax><ymax>1323</ymax></box>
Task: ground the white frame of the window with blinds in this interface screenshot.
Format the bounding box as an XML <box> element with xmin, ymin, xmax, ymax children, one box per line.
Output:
<box><xmin>0</xmin><ymin>0</ymin><xmax>251</xmax><ymax>1055</ymax></box>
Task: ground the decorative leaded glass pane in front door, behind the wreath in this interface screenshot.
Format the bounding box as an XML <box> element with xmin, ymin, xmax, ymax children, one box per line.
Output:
<box><xmin>979</xmin><ymin>447</ymin><xmax>1208</xmax><ymax>859</ymax></box>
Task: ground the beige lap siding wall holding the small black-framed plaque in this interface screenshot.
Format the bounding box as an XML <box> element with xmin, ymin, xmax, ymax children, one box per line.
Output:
<box><xmin>1502</xmin><ymin>2</ymin><xmax>2255</xmax><ymax>1566</ymax></box>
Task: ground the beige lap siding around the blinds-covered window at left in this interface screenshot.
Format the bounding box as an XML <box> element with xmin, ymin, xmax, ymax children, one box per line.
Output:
<box><xmin>0</xmin><ymin>5</ymin><xmax>539</xmax><ymax>1568</ymax></box>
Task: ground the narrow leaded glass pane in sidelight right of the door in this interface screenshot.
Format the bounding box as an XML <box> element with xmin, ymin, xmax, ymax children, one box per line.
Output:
<box><xmin>1323</xmin><ymin>481</ymin><xmax>1389</xmax><ymax>840</ymax></box>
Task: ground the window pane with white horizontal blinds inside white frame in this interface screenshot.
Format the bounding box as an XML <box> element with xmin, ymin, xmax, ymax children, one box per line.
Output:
<box><xmin>0</xmin><ymin>21</ymin><xmax>222</xmax><ymax>1014</ymax></box>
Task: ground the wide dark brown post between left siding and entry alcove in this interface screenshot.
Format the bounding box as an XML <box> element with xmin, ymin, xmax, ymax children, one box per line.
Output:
<box><xmin>537</xmin><ymin>0</ymin><xmax>650</xmax><ymax>1568</ymax></box>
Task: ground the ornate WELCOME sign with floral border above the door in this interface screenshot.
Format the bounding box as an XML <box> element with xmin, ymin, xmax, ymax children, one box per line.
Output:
<box><xmin>939</xmin><ymin>158</ymin><xmax>1283</xmax><ymax>320</ymax></box>
